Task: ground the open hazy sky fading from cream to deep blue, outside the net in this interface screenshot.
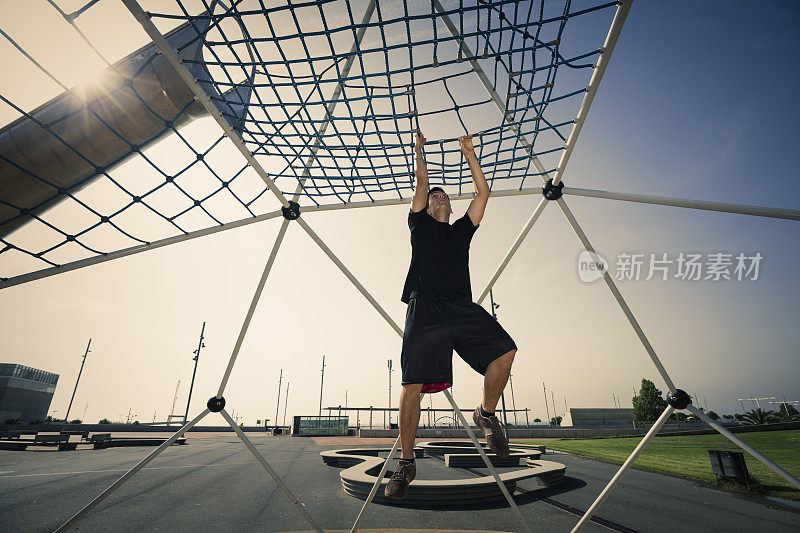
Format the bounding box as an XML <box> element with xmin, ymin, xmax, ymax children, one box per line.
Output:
<box><xmin>0</xmin><ymin>1</ymin><xmax>800</xmax><ymax>424</ymax></box>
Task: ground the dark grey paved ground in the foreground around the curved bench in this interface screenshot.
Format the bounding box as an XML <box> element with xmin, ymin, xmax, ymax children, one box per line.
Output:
<box><xmin>0</xmin><ymin>434</ymin><xmax>800</xmax><ymax>533</ymax></box>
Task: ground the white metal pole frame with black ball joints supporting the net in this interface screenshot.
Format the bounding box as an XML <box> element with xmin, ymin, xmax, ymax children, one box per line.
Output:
<box><xmin>32</xmin><ymin>0</ymin><xmax>800</xmax><ymax>531</ymax></box>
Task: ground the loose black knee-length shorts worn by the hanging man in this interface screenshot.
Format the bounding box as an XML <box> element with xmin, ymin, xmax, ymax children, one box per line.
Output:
<box><xmin>400</xmin><ymin>297</ymin><xmax>517</xmax><ymax>392</ymax></box>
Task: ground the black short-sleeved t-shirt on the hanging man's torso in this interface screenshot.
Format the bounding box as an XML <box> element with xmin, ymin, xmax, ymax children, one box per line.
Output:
<box><xmin>401</xmin><ymin>209</ymin><xmax>478</xmax><ymax>303</ymax></box>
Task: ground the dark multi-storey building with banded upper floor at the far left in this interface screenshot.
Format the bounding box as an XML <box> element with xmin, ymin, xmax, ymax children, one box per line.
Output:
<box><xmin>0</xmin><ymin>363</ymin><xmax>58</xmax><ymax>424</ymax></box>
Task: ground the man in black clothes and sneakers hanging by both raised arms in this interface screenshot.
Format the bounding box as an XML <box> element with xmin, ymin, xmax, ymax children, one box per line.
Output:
<box><xmin>384</xmin><ymin>132</ymin><xmax>517</xmax><ymax>499</ymax></box>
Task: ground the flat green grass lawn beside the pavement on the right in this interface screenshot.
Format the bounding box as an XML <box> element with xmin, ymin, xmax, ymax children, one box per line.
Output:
<box><xmin>516</xmin><ymin>430</ymin><xmax>800</xmax><ymax>501</ymax></box>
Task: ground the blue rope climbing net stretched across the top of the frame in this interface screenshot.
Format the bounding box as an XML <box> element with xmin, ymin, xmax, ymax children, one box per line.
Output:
<box><xmin>0</xmin><ymin>0</ymin><xmax>617</xmax><ymax>287</ymax></box>
